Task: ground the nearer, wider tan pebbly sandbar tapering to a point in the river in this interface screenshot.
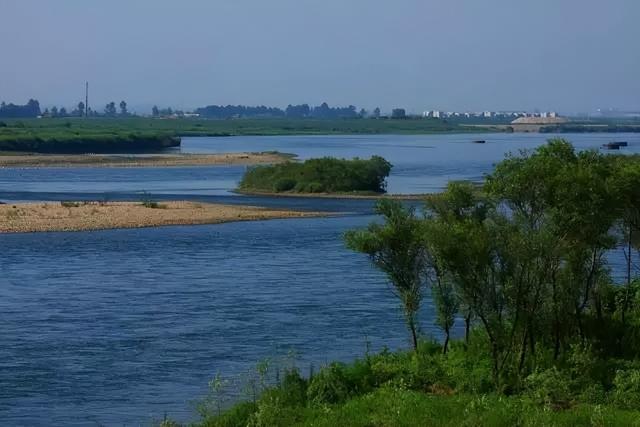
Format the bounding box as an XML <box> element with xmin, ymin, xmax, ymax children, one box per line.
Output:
<box><xmin>0</xmin><ymin>202</ymin><xmax>328</xmax><ymax>233</ymax></box>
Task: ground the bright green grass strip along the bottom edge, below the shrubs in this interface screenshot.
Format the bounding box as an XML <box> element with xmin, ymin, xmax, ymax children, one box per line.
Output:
<box><xmin>292</xmin><ymin>387</ymin><xmax>640</xmax><ymax>427</ymax></box>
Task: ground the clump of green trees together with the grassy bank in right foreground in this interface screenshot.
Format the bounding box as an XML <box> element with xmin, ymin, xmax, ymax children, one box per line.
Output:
<box><xmin>169</xmin><ymin>140</ymin><xmax>640</xmax><ymax>427</ymax></box>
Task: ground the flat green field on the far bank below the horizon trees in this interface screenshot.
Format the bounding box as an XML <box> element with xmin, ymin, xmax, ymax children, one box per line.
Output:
<box><xmin>0</xmin><ymin>117</ymin><xmax>491</xmax><ymax>153</ymax></box>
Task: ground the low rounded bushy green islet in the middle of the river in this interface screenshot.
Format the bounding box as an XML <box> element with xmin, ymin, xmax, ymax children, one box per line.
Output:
<box><xmin>239</xmin><ymin>156</ymin><xmax>391</xmax><ymax>194</ymax></box>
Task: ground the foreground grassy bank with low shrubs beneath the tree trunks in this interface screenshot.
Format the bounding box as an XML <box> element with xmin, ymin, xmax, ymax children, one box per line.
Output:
<box><xmin>189</xmin><ymin>335</ymin><xmax>640</xmax><ymax>427</ymax></box>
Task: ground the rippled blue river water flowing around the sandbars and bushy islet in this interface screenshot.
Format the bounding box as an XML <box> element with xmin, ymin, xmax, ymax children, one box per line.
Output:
<box><xmin>0</xmin><ymin>134</ymin><xmax>640</xmax><ymax>426</ymax></box>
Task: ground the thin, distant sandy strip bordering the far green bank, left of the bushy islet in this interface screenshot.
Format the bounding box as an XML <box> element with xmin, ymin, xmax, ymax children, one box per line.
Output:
<box><xmin>0</xmin><ymin>152</ymin><xmax>294</xmax><ymax>168</ymax></box>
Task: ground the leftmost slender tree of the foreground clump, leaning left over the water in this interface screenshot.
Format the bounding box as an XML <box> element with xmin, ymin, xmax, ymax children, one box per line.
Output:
<box><xmin>345</xmin><ymin>200</ymin><xmax>427</xmax><ymax>350</ymax></box>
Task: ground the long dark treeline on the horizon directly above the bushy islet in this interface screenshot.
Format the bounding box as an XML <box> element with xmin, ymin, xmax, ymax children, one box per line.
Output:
<box><xmin>195</xmin><ymin>102</ymin><xmax>372</xmax><ymax>119</ymax></box>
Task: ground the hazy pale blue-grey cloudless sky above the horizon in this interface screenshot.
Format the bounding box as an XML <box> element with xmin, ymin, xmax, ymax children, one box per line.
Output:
<box><xmin>0</xmin><ymin>0</ymin><xmax>640</xmax><ymax>112</ymax></box>
